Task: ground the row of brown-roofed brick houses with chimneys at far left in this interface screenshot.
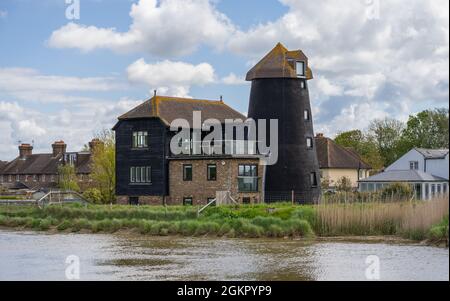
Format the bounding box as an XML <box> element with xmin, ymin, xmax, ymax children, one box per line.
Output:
<box><xmin>0</xmin><ymin>139</ymin><xmax>100</xmax><ymax>190</ymax></box>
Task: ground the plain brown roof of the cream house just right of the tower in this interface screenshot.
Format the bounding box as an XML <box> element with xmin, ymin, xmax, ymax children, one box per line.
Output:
<box><xmin>315</xmin><ymin>137</ymin><xmax>372</xmax><ymax>169</ymax></box>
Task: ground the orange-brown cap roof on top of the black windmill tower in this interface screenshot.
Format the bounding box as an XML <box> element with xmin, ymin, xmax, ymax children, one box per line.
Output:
<box><xmin>246</xmin><ymin>43</ymin><xmax>313</xmax><ymax>81</ymax></box>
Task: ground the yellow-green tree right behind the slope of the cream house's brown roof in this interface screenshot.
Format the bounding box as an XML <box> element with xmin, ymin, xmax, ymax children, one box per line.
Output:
<box><xmin>335</xmin><ymin>130</ymin><xmax>384</xmax><ymax>170</ymax></box>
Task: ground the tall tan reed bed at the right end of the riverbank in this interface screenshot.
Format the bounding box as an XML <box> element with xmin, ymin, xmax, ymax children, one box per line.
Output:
<box><xmin>314</xmin><ymin>197</ymin><xmax>449</xmax><ymax>239</ymax></box>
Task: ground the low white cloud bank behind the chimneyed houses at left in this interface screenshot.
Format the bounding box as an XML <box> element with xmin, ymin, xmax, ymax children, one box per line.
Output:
<box><xmin>0</xmin><ymin>99</ymin><xmax>141</xmax><ymax>160</ymax></box>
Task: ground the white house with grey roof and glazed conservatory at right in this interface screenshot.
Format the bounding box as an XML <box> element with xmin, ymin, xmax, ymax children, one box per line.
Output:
<box><xmin>359</xmin><ymin>148</ymin><xmax>449</xmax><ymax>200</ymax></box>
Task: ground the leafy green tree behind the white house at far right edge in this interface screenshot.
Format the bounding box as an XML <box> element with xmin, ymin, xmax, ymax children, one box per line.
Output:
<box><xmin>404</xmin><ymin>109</ymin><xmax>449</xmax><ymax>150</ymax></box>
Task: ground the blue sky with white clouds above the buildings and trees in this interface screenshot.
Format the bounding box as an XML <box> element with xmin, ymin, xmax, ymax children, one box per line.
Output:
<box><xmin>0</xmin><ymin>0</ymin><xmax>449</xmax><ymax>160</ymax></box>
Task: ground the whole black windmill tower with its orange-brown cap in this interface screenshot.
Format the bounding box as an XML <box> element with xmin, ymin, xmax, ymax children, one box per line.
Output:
<box><xmin>246</xmin><ymin>43</ymin><xmax>320</xmax><ymax>203</ymax></box>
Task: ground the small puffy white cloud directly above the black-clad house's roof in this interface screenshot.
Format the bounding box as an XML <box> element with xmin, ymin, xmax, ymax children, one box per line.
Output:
<box><xmin>127</xmin><ymin>59</ymin><xmax>215</xmax><ymax>97</ymax></box>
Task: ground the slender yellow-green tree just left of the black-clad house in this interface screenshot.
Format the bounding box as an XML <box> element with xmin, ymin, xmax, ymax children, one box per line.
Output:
<box><xmin>91</xmin><ymin>130</ymin><xmax>116</xmax><ymax>203</ymax></box>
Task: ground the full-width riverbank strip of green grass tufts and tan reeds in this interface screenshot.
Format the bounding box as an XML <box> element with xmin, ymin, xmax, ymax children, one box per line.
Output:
<box><xmin>0</xmin><ymin>198</ymin><xmax>449</xmax><ymax>241</ymax></box>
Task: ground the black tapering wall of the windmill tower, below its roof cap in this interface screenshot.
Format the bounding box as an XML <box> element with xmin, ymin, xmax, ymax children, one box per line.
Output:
<box><xmin>249</xmin><ymin>78</ymin><xmax>320</xmax><ymax>202</ymax></box>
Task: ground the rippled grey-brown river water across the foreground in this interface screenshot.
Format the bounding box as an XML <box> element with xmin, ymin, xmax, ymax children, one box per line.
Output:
<box><xmin>0</xmin><ymin>230</ymin><xmax>449</xmax><ymax>281</ymax></box>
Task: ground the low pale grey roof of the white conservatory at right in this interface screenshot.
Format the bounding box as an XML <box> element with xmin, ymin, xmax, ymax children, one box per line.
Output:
<box><xmin>360</xmin><ymin>170</ymin><xmax>448</xmax><ymax>182</ymax></box>
